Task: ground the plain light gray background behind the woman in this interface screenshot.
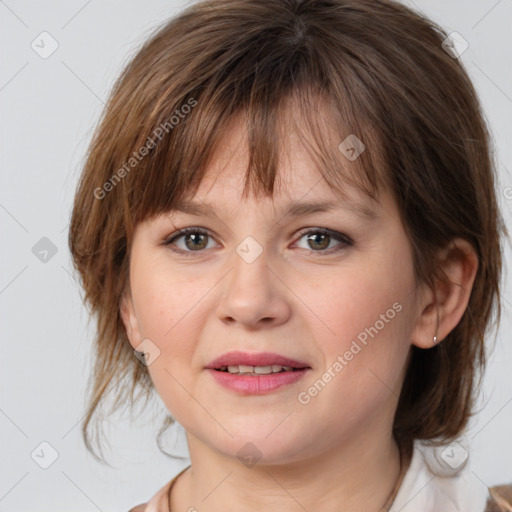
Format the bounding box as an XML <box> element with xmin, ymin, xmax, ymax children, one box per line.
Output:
<box><xmin>0</xmin><ymin>0</ymin><xmax>512</xmax><ymax>512</ymax></box>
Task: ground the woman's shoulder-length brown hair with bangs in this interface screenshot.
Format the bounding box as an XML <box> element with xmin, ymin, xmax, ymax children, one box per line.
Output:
<box><xmin>69</xmin><ymin>0</ymin><xmax>508</xmax><ymax>464</ymax></box>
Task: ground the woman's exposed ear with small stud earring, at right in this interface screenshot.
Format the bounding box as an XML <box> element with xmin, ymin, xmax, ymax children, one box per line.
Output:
<box><xmin>411</xmin><ymin>238</ymin><xmax>478</xmax><ymax>348</ymax></box>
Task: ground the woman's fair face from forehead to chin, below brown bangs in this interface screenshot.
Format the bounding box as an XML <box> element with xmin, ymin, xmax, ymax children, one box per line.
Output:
<box><xmin>122</xmin><ymin>114</ymin><xmax>426</xmax><ymax>463</ymax></box>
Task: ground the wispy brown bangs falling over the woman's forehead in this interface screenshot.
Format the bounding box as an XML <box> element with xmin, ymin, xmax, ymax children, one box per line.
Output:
<box><xmin>122</xmin><ymin>60</ymin><xmax>388</xmax><ymax>248</ymax></box>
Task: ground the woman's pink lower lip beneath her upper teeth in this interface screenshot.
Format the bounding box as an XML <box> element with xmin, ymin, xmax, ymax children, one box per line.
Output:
<box><xmin>207</xmin><ymin>368</ymin><xmax>310</xmax><ymax>395</ymax></box>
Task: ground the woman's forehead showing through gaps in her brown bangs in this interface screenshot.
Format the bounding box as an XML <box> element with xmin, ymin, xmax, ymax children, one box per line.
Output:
<box><xmin>170</xmin><ymin>112</ymin><xmax>379</xmax><ymax>220</ymax></box>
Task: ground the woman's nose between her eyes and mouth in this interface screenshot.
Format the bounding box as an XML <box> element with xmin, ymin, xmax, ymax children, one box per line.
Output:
<box><xmin>217</xmin><ymin>247</ymin><xmax>291</xmax><ymax>330</ymax></box>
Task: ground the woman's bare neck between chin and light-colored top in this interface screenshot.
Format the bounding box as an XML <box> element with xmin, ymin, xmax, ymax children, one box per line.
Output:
<box><xmin>171</xmin><ymin>426</ymin><xmax>401</xmax><ymax>512</ymax></box>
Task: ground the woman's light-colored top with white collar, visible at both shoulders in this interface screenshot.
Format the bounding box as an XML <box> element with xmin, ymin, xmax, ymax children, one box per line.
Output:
<box><xmin>129</xmin><ymin>441</ymin><xmax>512</xmax><ymax>512</ymax></box>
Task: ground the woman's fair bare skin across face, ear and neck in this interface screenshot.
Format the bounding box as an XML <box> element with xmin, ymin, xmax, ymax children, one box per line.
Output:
<box><xmin>121</xmin><ymin>110</ymin><xmax>478</xmax><ymax>512</ymax></box>
